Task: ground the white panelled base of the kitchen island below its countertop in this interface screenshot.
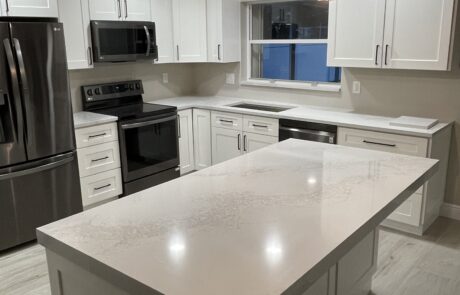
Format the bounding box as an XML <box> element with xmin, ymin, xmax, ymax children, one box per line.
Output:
<box><xmin>46</xmin><ymin>230</ymin><xmax>378</xmax><ymax>295</ymax></box>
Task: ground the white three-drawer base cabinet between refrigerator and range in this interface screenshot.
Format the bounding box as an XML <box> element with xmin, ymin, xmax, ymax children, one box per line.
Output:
<box><xmin>75</xmin><ymin>123</ymin><xmax>123</xmax><ymax>208</ymax></box>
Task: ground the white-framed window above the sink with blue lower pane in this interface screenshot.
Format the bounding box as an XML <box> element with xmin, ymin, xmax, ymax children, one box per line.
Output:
<box><xmin>247</xmin><ymin>0</ymin><xmax>341</xmax><ymax>90</ymax></box>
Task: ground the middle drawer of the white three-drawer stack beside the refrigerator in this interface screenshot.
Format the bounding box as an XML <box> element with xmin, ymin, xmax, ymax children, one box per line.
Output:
<box><xmin>77</xmin><ymin>141</ymin><xmax>120</xmax><ymax>177</ymax></box>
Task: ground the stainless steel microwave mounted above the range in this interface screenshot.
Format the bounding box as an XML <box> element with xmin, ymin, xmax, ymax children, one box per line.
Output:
<box><xmin>91</xmin><ymin>21</ymin><xmax>158</xmax><ymax>62</ymax></box>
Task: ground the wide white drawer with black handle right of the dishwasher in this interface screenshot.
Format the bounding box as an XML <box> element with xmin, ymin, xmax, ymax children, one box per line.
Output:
<box><xmin>338</xmin><ymin>128</ymin><xmax>428</xmax><ymax>157</ymax></box>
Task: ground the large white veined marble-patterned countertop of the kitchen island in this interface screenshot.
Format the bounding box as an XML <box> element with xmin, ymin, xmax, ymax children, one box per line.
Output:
<box><xmin>37</xmin><ymin>139</ymin><xmax>437</xmax><ymax>294</ymax></box>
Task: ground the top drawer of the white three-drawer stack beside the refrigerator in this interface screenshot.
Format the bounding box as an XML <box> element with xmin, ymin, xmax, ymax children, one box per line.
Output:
<box><xmin>75</xmin><ymin>123</ymin><xmax>118</xmax><ymax>148</ymax></box>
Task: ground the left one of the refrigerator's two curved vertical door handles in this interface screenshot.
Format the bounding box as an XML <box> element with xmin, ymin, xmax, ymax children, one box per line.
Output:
<box><xmin>3</xmin><ymin>39</ymin><xmax>24</xmax><ymax>142</ymax></box>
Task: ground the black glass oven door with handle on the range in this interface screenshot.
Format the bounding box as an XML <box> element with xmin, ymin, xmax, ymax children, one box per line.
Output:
<box><xmin>119</xmin><ymin>112</ymin><xmax>179</xmax><ymax>182</ymax></box>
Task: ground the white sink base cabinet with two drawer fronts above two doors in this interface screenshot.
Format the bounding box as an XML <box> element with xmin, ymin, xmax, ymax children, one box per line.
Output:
<box><xmin>211</xmin><ymin>112</ymin><xmax>278</xmax><ymax>165</ymax></box>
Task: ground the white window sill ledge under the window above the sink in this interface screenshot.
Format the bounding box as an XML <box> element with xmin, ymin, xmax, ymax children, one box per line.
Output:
<box><xmin>240</xmin><ymin>79</ymin><xmax>342</xmax><ymax>92</ymax></box>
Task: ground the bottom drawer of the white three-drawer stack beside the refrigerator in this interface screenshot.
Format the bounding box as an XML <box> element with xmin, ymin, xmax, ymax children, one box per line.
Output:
<box><xmin>80</xmin><ymin>169</ymin><xmax>123</xmax><ymax>207</ymax></box>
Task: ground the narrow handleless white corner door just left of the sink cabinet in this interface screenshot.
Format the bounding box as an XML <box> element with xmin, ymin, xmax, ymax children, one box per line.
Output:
<box><xmin>193</xmin><ymin>109</ymin><xmax>212</xmax><ymax>170</ymax></box>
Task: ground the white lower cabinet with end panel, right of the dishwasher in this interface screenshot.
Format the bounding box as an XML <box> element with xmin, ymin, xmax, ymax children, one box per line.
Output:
<box><xmin>338</xmin><ymin>127</ymin><xmax>451</xmax><ymax>235</ymax></box>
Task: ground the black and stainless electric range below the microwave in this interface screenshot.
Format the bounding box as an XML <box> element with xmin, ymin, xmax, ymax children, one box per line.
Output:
<box><xmin>81</xmin><ymin>80</ymin><xmax>180</xmax><ymax>196</ymax></box>
